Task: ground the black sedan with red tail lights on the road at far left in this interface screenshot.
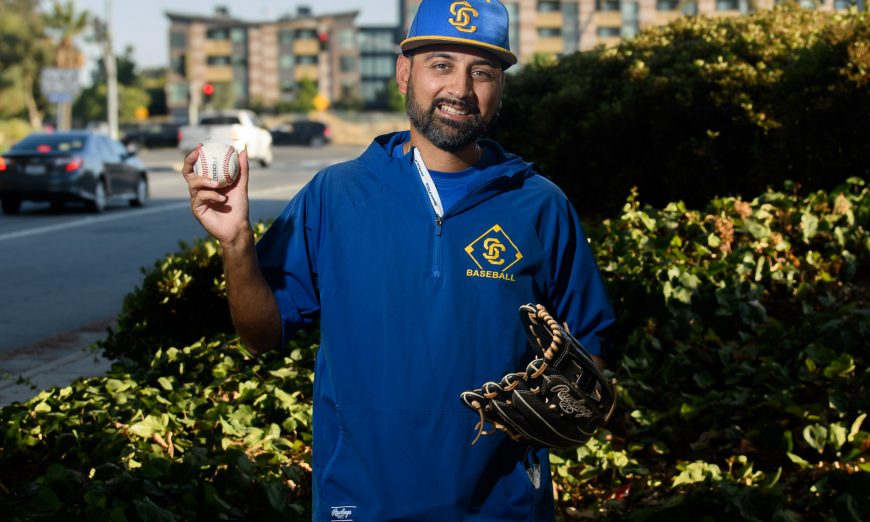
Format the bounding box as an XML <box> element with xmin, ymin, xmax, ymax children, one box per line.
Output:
<box><xmin>0</xmin><ymin>131</ymin><xmax>148</xmax><ymax>214</ymax></box>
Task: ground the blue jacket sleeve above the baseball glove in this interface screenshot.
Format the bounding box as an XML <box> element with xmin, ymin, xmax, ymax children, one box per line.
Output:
<box><xmin>544</xmin><ymin>195</ymin><xmax>615</xmax><ymax>357</ymax></box>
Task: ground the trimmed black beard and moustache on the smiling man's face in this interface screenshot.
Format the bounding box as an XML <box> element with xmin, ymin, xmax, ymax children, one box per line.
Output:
<box><xmin>405</xmin><ymin>83</ymin><xmax>490</xmax><ymax>152</ymax></box>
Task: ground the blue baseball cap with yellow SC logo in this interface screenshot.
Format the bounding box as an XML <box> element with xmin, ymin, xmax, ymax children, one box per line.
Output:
<box><xmin>399</xmin><ymin>0</ymin><xmax>517</xmax><ymax>69</ymax></box>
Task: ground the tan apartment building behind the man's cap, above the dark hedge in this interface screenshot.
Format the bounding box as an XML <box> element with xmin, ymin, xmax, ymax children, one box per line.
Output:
<box><xmin>399</xmin><ymin>0</ymin><xmax>866</xmax><ymax>64</ymax></box>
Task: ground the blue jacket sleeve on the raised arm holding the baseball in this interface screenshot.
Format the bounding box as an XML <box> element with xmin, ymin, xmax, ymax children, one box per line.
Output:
<box><xmin>257</xmin><ymin>177</ymin><xmax>322</xmax><ymax>346</ymax></box>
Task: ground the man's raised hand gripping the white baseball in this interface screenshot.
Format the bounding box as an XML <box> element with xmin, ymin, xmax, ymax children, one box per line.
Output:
<box><xmin>181</xmin><ymin>145</ymin><xmax>251</xmax><ymax>245</ymax></box>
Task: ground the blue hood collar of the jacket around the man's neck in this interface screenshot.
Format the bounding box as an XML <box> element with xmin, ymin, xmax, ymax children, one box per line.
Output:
<box><xmin>359</xmin><ymin>131</ymin><xmax>536</xmax><ymax>215</ymax></box>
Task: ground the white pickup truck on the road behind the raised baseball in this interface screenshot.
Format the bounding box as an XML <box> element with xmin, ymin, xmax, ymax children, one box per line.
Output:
<box><xmin>178</xmin><ymin>109</ymin><xmax>272</xmax><ymax>167</ymax></box>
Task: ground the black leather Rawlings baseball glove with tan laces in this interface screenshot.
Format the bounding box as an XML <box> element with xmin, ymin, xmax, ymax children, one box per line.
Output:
<box><xmin>461</xmin><ymin>304</ymin><xmax>616</xmax><ymax>448</ymax></box>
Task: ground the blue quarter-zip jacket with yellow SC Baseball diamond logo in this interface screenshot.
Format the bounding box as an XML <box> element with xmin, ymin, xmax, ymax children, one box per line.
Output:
<box><xmin>258</xmin><ymin>132</ymin><xmax>613</xmax><ymax>522</ymax></box>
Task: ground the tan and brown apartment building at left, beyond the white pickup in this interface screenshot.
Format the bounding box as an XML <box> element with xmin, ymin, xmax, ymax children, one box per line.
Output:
<box><xmin>165</xmin><ymin>7</ymin><xmax>360</xmax><ymax>119</ymax></box>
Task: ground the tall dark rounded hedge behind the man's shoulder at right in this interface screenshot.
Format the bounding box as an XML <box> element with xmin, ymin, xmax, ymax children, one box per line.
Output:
<box><xmin>494</xmin><ymin>6</ymin><xmax>870</xmax><ymax>216</ymax></box>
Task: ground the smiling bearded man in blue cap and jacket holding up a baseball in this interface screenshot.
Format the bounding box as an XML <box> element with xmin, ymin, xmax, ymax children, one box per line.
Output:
<box><xmin>184</xmin><ymin>0</ymin><xmax>613</xmax><ymax>521</ymax></box>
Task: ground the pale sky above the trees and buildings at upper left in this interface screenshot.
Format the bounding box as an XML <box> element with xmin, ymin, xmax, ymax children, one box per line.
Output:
<box><xmin>73</xmin><ymin>0</ymin><xmax>399</xmax><ymax>73</ymax></box>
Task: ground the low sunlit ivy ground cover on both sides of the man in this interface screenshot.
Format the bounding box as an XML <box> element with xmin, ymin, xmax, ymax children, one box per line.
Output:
<box><xmin>0</xmin><ymin>179</ymin><xmax>870</xmax><ymax>521</ymax></box>
